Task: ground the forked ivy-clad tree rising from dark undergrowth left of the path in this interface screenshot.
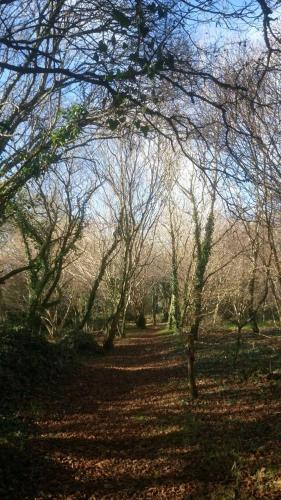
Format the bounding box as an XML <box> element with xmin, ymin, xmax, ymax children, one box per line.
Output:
<box><xmin>7</xmin><ymin>164</ymin><xmax>97</xmax><ymax>328</ymax></box>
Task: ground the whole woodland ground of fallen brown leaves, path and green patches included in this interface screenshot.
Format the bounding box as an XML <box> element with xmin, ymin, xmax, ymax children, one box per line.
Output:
<box><xmin>0</xmin><ymin>328</ymin><xmax>281</xmax><ymax>500</ymax></box>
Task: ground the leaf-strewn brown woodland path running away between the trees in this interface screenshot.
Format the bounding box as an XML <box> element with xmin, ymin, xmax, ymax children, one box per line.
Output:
<box><xmin>28</xmin><ymin>330</ymin><xmax>195</xmax><ymax>499</ymax></box>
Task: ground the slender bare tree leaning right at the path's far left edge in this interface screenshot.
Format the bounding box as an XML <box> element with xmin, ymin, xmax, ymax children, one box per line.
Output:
<box><xmin>101</xmin><ymin>137</ymin><xmax>164</xmax><ymax>349</ymax></box>
